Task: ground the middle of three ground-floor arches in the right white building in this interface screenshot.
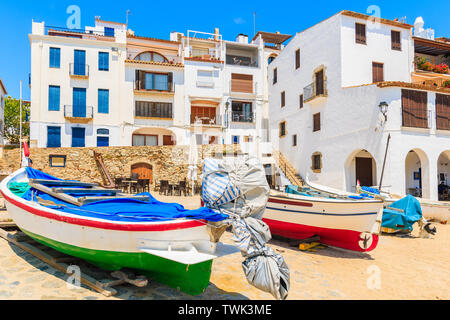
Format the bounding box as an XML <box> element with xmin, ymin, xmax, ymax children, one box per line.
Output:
<box><xmin>405</xmin><ymin>149</ymin><xmax>430</xmax><ymax>198</ymax></box>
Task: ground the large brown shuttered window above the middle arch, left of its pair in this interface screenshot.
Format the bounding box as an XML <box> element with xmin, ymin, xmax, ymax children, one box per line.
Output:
<box><xmin>402</xmin><ymin>89</ymin><xmax>428</xmax><ymax>128</ymax></box>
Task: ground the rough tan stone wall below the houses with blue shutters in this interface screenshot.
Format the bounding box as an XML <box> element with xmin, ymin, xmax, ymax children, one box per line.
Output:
<box><xmin>0</xmin><ymin>145</ymin><xmax>240</xmax><ymax>184</ymax></box>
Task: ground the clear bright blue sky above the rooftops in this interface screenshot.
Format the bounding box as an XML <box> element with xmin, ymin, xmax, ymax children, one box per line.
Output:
<box><xmin>0</xmin><ymin>0</ymin><xmax>450</xmax><ymax>100</ymax></box>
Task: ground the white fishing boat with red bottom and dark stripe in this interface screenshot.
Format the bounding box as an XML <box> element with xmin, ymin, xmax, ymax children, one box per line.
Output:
<box><xmin>263</xmin><ymin>186</ymin><xmax>383</xmax><ymax>252</ymax></box>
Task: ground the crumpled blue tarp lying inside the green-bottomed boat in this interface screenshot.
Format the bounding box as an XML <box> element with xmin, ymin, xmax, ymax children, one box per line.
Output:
<box><xmin>19</xmin><ymin>168</ymin><xmax>228</xmax><ymax>222</ymax></box>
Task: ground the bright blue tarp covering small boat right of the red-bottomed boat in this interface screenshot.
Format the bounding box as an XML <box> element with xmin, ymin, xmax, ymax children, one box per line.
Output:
<box><xmin>381</xmin><ymin>195</ymin><xmax>422</xmax><ymax>231</ymax></box>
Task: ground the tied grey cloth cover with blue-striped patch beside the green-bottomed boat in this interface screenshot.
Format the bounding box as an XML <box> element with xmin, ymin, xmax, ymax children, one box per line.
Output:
<box><xmin>202</xmin><ymin>157</ymin><xmax>290</xmax><ymax>299</ymax></box>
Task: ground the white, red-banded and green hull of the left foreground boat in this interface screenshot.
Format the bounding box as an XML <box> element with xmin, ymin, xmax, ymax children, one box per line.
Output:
<box><xmin>0</xmin><ymin>169</ymin><xmax>216</xmax><ymax>295</ymax></box>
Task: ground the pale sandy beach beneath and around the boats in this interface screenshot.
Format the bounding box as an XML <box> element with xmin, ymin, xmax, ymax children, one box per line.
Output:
<box><xmin>0</xmin><ymin>195</ymin><xmax>450</xmax><ymax>300</ymax></box>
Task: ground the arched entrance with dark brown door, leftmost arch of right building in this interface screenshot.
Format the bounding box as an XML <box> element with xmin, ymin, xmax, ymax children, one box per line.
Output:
<box><xmin>345</xmin><ymin>149</ymin><xmax>377</xmax><ymax>192</ymax></box>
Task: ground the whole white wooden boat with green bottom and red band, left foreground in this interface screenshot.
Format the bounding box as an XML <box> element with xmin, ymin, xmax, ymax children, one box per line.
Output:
<box><xmin>0</xmin><ymin>168</ymin><xmax>229</xmax><ymax>295</ymax></box>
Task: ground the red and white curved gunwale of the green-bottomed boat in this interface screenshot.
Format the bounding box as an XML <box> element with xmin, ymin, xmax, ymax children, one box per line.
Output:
<box><xmin>0</xmin><ymin>168</ymin><xmax>208</xmax><ymax>231</ymax></box>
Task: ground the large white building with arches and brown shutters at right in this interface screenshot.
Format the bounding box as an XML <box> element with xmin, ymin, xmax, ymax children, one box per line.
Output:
<box><xmin>269</xmin><ymin>11</ymin><xmax>450</xmax><ymax>200</ymax></box>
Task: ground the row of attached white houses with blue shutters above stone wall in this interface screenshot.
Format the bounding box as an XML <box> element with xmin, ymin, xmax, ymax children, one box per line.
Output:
<box><xmin>29</xmin><ymin>18</ymin><xmax>290</xmax><ymax>158</ymax></box>
